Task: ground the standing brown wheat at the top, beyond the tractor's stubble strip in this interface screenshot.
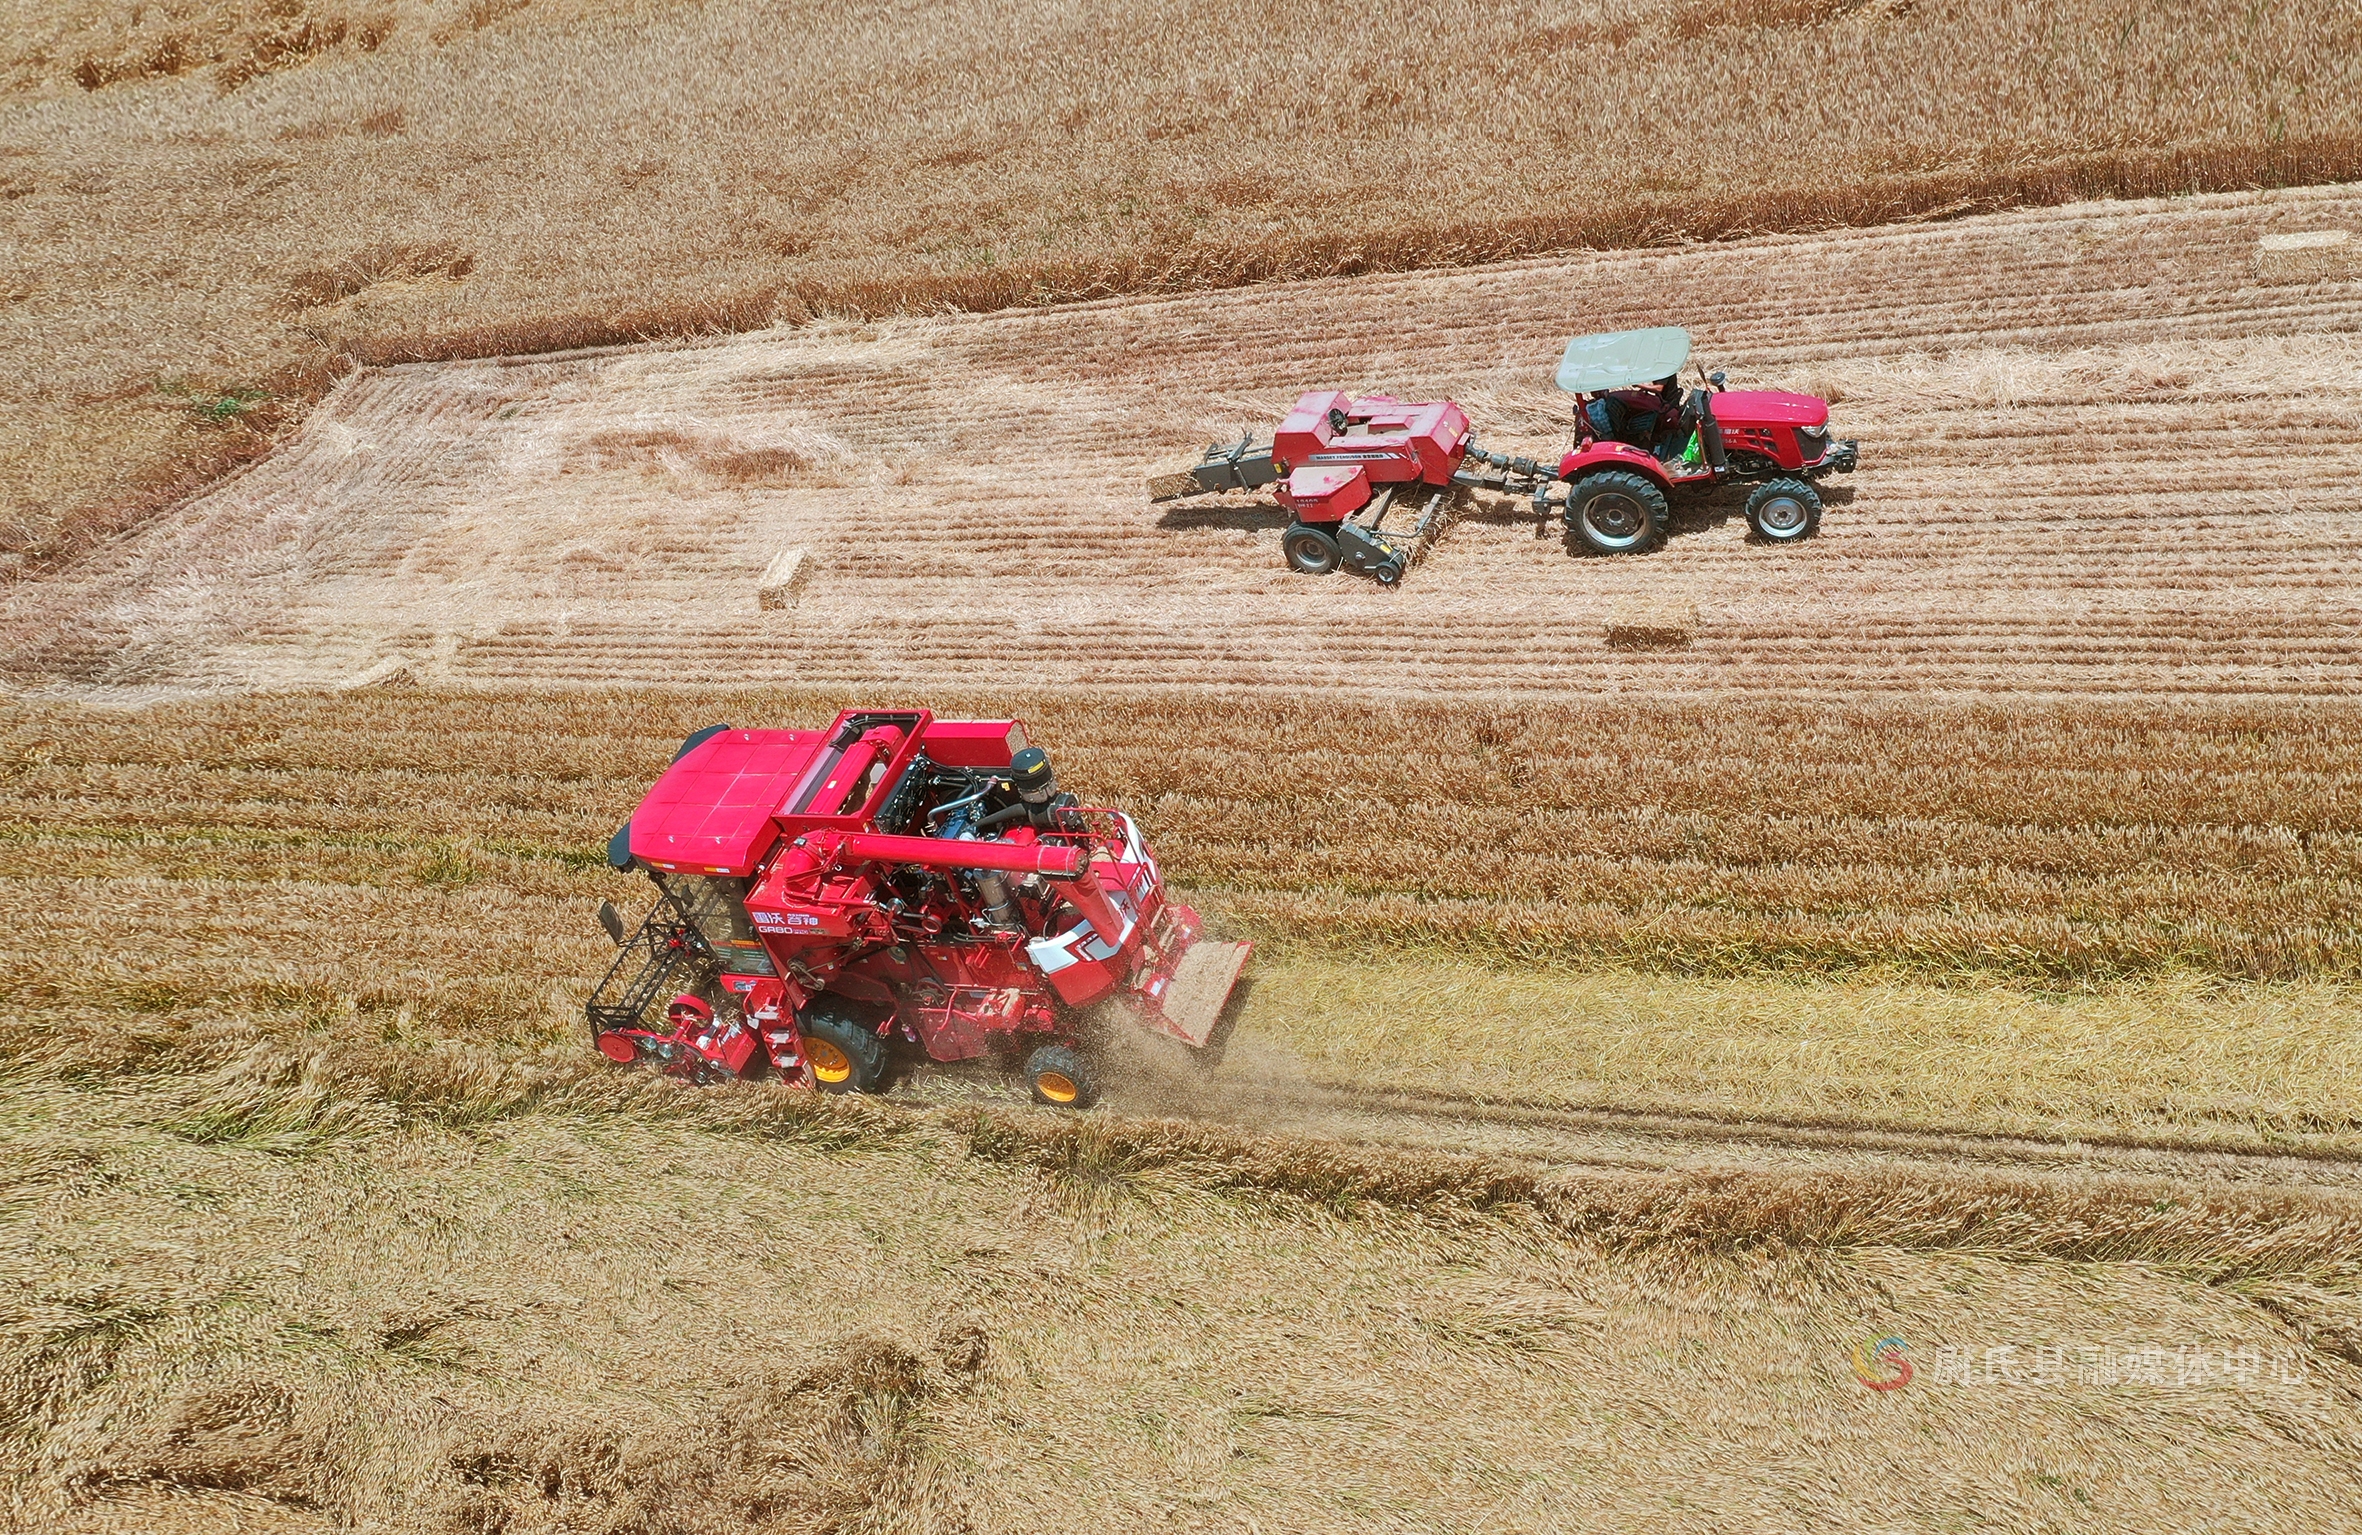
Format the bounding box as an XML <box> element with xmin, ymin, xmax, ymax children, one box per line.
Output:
<box><xmin>0</xmin><ymin>0</ymin><xmax>2362</xmax><ymax>580</ymax></box>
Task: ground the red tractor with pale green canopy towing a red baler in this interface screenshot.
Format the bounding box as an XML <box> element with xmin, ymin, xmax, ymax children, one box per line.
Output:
<box><xmin>1148</xmin><ymin>326</ymin><xmax>1859</xmax><ymax>586</ymax></box>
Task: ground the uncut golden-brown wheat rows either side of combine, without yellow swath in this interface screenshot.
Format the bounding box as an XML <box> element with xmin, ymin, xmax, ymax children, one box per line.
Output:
<box><xmin>7</xmin><ymin>690</ymin><xmax>2362</xmax><ymax>991</ymax></box>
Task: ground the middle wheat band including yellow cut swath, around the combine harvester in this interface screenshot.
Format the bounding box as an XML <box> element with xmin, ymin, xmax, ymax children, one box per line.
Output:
<box><xmin>0</xmin><ymin>690</ymin><xmax>2362</xmax><ymax>1133</ymax></box>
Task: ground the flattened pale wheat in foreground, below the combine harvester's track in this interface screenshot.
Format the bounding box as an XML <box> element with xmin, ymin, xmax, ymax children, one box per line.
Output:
<box><xmin>18</xmin><ymin>1020</ymin><xmax>2362</xmax><ymax>1535</ymax></box>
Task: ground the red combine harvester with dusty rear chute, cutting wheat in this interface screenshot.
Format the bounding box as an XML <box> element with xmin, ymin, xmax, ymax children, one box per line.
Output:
<box><xmin>588</xmin><ymin>708</ymin><xmax>1249</xmax><ymax>1108</ymax></box>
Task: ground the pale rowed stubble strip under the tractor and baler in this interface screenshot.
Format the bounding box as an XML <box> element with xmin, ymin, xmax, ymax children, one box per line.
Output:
<box><xmin>5</xmin><ymin>189</ymin><xmax>2362</xmax><ymax>697</ymax></box>
